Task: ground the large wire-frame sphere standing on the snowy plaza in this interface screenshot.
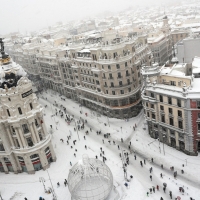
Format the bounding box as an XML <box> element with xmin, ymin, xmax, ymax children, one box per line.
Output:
<box><xmin>68</xmin><ymin>155</ymin><xmax>113</xmax><ymax>200</ymax></box>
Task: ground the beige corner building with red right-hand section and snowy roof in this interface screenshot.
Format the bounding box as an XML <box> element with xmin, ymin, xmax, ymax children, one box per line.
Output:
<box><xmin>142</xmin><ymin>62</ymin><xmax>200</xmax><ymax>155</ymax></box>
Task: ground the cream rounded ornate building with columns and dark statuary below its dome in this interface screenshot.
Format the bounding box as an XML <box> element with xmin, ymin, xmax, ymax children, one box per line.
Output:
<box><xmin>0</xmin><ymin>40</ymin><xmax>56</xmax><ymax>173</ymax></box>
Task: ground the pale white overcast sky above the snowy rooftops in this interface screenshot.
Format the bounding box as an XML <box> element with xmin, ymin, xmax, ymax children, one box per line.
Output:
<box><xmin>0</xmin><ymin>0</ymin><xmax>183</xmax><ymax>35</ymax></box>
